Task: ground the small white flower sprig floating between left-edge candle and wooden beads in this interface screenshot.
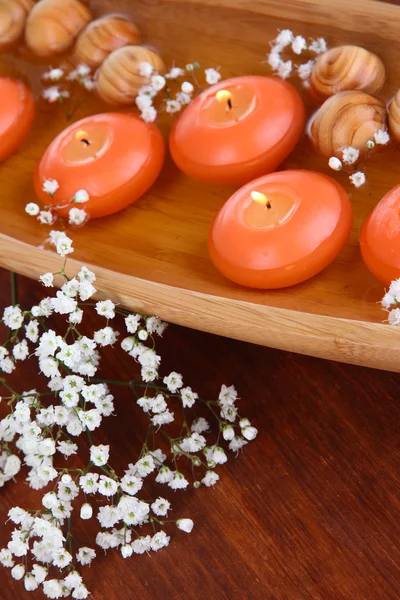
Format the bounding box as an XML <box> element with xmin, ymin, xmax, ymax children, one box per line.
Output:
<box><xmin>42</xmin><ymin>64</ymin><xmax>95</xmax><ymax>104</ymax></box>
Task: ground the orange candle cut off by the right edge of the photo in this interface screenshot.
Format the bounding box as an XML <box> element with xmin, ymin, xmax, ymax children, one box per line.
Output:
<box><xmin>360</xmin><ymin>185</ymin><xmax>400</xmax><ymax>284</ymax></box>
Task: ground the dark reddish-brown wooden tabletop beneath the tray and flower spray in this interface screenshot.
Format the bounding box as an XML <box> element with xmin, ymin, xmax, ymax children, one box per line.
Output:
<box><xmin>0</xmin><ymin>271</ymin><xmax>400</xmax><ymax>600</ymax></box>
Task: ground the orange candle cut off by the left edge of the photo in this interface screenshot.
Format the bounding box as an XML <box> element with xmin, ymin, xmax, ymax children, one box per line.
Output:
<box><xmin>0</xmin><ymin>77</ymin><xmax>35</xmax><ymax>161</ymax></box>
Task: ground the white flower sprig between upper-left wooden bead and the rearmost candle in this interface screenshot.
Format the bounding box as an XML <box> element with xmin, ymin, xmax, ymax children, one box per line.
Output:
<box><xmin>135</xmin><ymin>62</ymin><xmax>221</xmax><ymax>123</ymax></box>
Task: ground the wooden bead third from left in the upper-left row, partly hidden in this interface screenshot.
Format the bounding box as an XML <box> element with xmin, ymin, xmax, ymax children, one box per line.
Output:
<box><xmin>74</xmin><ymin>15</ymin><xmax>140</xmax><ymax>68</ymax></box>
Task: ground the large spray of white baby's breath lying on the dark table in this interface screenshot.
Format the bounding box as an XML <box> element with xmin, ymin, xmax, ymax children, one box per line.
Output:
<box><xmin>0</xmin><ymin>234</ymin><xmax>257</xmax><ymax>599</ymax></box>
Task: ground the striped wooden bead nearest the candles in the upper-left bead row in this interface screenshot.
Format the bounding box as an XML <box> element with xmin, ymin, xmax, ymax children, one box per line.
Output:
<box><xmin>96</xmin><ymin>46</ymin><xmax>165</xmax><ymax>106</ymax></box>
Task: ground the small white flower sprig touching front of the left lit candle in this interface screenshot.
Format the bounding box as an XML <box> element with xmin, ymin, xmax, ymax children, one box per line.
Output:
<box><xmin>25</xmin><ymin>179</ymin><xmax>90</xmax><ymax>226</ymax></box>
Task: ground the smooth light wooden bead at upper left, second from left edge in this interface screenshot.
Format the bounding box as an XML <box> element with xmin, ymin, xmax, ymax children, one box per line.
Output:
<box><xmin>25</xmin><ymin>0</ymin><xmax>92</xmax><ymax>56</ymax></box>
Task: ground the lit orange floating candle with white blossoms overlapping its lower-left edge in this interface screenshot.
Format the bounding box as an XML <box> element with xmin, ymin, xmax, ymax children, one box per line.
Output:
<box><xmin>35</xmin><ymin>113</ymin><xmax>165</xmax><ymax>219</ymax></box>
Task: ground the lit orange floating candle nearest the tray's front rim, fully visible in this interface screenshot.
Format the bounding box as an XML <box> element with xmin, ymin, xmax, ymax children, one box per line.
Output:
<box><xmin>208</xmin><ymin>171</ymin><xmax>352</xmax><ymax>289</ymax></box>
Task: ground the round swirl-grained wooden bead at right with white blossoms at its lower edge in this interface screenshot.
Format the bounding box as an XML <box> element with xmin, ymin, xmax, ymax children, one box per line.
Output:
<box><xmin>311</xmin><ymin>92</ymin><xmax>387</xmax><ymax>157</ymax></box>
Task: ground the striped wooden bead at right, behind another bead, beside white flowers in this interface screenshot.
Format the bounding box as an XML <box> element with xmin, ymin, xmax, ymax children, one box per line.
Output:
<box><xmin>310</xmin><ymin>46</ymin><xmax>386</xmax><ymax>99</ymax></box>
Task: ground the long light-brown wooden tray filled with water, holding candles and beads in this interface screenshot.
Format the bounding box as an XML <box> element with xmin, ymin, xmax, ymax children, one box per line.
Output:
<box><xmin>0</xmin><ymin>0</ymin><xmax>400</xmax><ymax>371</ymax></box>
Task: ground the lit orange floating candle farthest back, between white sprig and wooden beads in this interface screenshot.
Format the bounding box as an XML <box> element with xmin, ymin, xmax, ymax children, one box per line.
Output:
<box><xmin>169</xmin><ymin>76</ymin><xmax>304</xmax><ymax>184</ymax></box>
